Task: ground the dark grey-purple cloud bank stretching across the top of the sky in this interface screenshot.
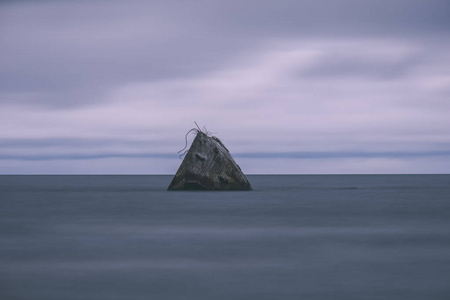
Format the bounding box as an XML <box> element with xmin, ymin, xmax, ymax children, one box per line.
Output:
<box><xmin>0</xmin><ymin>0</ymin><xmax>450</xmax><ymax>107</ymax></box>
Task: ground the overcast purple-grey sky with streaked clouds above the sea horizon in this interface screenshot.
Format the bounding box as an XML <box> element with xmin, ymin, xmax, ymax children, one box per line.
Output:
<box><xmin>0</xmin><ymin>0</ymin><xmax>450</xmax><ymax>174</ymax></box>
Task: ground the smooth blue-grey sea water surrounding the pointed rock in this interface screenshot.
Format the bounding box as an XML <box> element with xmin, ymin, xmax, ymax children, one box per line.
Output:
<box><xmin>0</xmin><ymin>175</ymin><xmax>450</xmax><ymax>300</ymax></box>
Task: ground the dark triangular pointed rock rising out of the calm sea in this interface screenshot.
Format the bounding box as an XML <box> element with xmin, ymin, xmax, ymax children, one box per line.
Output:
<box><xmin>168</xmin><ymin>131</ymin><xmax>252</xmax><ymax>191</ymax></box>
